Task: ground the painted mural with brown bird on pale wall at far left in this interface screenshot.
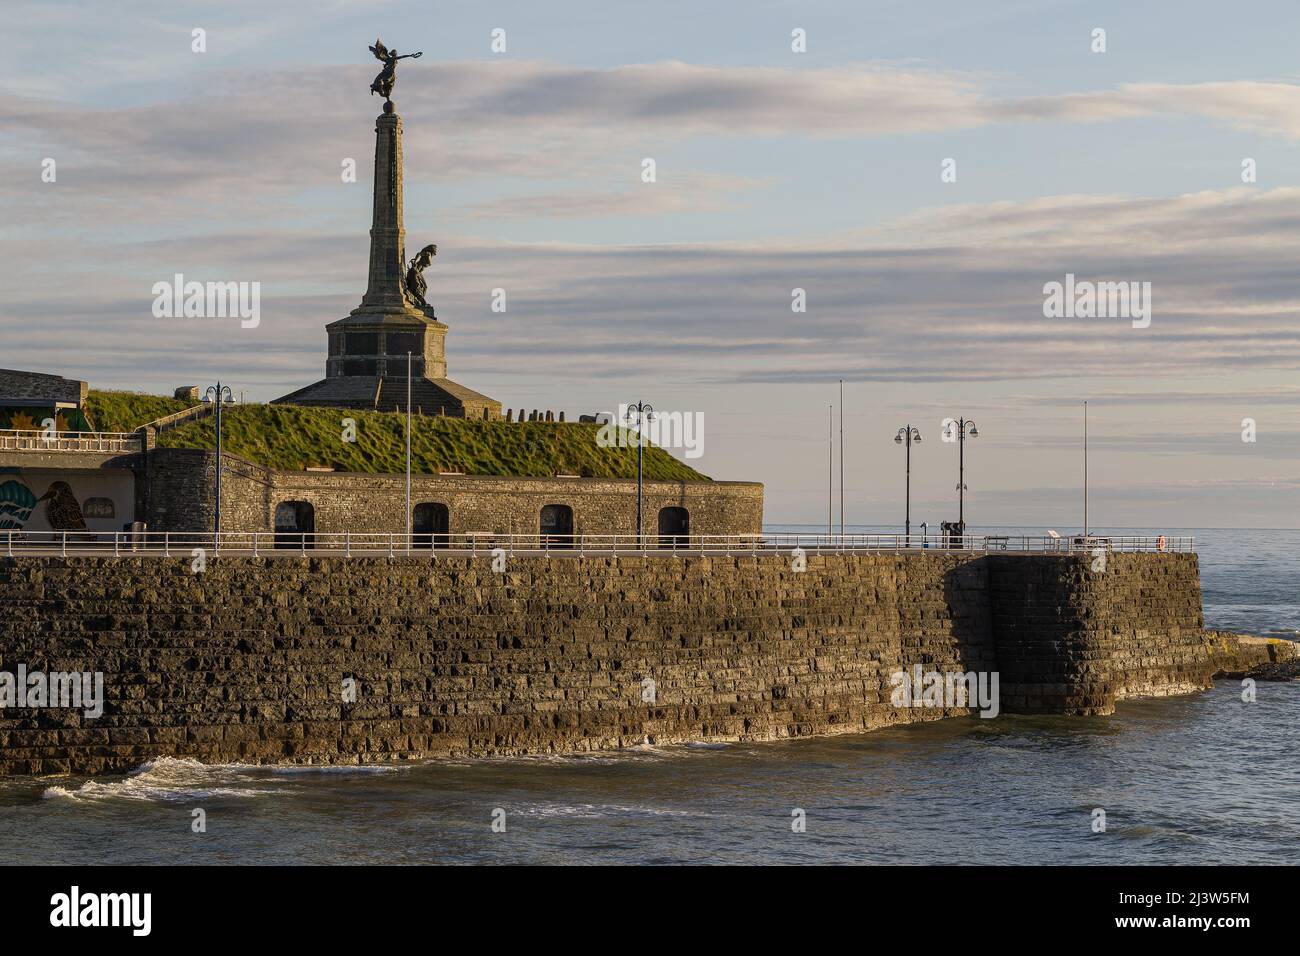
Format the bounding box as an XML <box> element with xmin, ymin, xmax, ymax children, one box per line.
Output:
<box><xmin>0</xmin><ymin>468</ymin><xmax>135</xmax><ymax>532</ymax></box>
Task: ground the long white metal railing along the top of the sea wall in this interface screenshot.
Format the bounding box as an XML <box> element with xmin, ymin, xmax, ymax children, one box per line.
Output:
<box><xmin>0</xmin><ymin>531</ymin><xmax>1196</xmax><ymax>557</ymax></box>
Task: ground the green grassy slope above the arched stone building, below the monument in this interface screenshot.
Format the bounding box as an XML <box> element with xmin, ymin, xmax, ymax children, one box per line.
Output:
<box><xmin>156</xmin><ymin>403</ymin><xmax>709</xmax><ymax>481</ymax></box>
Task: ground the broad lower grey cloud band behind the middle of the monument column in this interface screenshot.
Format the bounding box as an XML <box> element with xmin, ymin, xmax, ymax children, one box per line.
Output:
<box><xmin>0</xmin><ymin>189</ymin><xmax>1300</xmax><ymax>397</ymax></box>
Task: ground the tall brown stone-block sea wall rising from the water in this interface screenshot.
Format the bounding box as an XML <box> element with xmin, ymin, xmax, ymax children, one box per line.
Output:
<box><xmin>0</xmin><ymin>551</ymin><xmax>1237</xmax><ymax>774</ymax></box>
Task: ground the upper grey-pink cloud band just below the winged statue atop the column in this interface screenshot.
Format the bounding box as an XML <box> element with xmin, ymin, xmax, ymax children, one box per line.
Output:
<box><xmin>0</xmin><ymin>60</ymin><xmax>1300</xmax><ymax>235</ymax></box>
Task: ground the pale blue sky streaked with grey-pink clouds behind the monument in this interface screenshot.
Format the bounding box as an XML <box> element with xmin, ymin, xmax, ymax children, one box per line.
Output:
<box><xmin>0</xmin><ymin>0</ymin><xmax>1300</xmax><ymax>532</ymax></box>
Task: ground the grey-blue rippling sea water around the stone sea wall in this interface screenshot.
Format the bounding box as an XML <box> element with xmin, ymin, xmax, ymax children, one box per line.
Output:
<box><xmin>0</xmin><ymin>528</ymin><xmax>1300</xmax><ymax>865</ymax></box>
